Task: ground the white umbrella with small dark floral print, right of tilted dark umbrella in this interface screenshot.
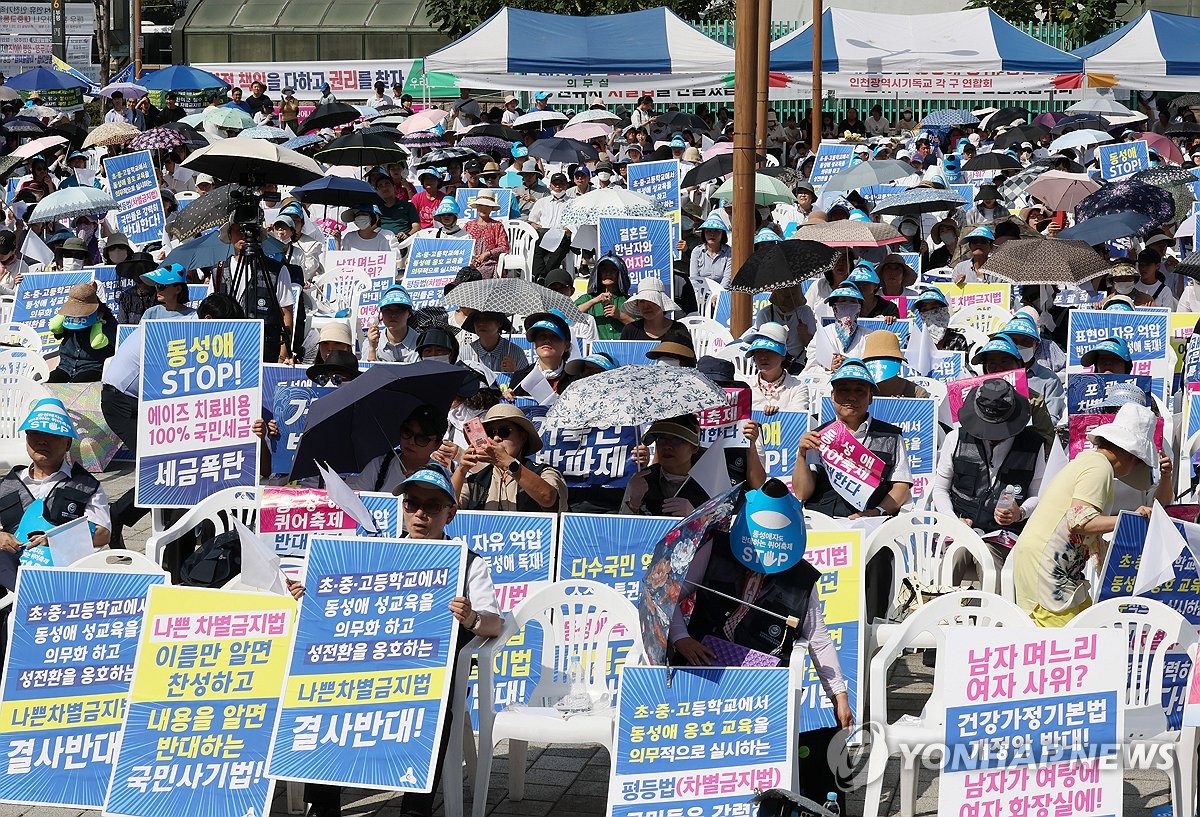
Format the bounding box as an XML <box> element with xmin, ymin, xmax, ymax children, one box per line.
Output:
<box><xmin>541</xmin><ymin>366</ymin><xmax>728</xmax><ymax>431</ymax></box>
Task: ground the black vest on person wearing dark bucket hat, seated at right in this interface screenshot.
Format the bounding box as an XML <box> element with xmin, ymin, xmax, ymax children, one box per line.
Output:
<box><xmin>950</xmin><ymin>426</ymin><xmax>1045</xmax><ymax>533</ymax></box>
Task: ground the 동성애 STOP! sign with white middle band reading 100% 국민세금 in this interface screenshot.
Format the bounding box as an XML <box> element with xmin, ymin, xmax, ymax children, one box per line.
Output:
<box><xmin>134</xmin><ymin>320</ymin><xmax>263</xmax><ymax>507</ymax></box>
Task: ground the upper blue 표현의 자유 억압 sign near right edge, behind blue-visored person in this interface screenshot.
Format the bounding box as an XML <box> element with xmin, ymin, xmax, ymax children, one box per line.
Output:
<box><xmin>1067</xmin><ymin>307</ymin><xmax>1172</xmax><ymax>401</ymax></box>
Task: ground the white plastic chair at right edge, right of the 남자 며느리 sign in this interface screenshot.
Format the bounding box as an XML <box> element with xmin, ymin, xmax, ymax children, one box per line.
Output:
<box><xmin>1067</xmin><ymin>596</ymin><xmax>1200</xmax><ymax>815</ymax></box>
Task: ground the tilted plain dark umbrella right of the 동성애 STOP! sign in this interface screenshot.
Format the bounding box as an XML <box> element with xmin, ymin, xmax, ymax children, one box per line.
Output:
<box><xmin>289</xmin><ymin>360</ymin><xmax>468</xmax><ymax>480</ymax></box>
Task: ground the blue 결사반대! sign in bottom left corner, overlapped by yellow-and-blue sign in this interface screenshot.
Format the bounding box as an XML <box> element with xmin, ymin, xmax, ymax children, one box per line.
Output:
<box><xmin>0</xmin><ymin>567</ymin><xmax>166</xmax><ymax>809</ymax></box>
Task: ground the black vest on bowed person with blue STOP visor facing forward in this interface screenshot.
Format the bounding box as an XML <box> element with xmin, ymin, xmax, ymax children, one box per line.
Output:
<box><xmin>688</xmin><ymin>530</ymin><xmax>821</xmax><ymax>666</ymax></box>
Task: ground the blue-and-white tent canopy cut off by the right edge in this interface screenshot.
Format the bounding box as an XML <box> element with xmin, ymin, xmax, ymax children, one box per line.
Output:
<box><xmin>1072</xmin><ymin>11</ymin><xmax>1200</xmax><ymax>91</ymax></box>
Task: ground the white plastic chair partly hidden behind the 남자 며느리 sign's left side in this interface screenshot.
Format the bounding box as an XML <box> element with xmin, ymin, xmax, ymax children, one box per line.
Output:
<box><xmin>863</xmin><ymin>590</ymin><xmax>1033</xmax><ymax>817</ymax></box>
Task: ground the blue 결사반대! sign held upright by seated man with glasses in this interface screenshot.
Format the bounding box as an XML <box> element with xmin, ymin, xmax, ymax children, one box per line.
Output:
<box><xmin>268</xmin><ymin>536</ymin><xmax>467</xmax><ymax>792</ymax></box>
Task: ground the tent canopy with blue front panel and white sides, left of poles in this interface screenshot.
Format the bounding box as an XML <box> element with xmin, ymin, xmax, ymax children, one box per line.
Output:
<box><xmin>425</xmin><ymin>8</ymin><xmax>733</xmax><ymax>92</ymax></box>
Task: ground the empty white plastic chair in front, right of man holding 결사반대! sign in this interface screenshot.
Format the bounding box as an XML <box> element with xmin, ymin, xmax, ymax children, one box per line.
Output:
<box><xmin>468</xmin><ymin>581</ymin><xmax>642</xmax><ymax>817</ymax></box>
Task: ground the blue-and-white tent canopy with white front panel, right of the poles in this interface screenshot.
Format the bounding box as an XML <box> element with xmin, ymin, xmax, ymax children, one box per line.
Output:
<box><xmin>770</xmin><ymin>8</ymin><xmax>1084</xmax><ymax>97</ymax></box>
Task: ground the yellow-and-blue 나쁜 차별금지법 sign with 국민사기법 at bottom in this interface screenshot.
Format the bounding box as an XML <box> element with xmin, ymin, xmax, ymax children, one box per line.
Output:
<box><xmin>104</xmin><ymin>583</ymin><xmax>296</xmax><ymax>817</ymax></box>
